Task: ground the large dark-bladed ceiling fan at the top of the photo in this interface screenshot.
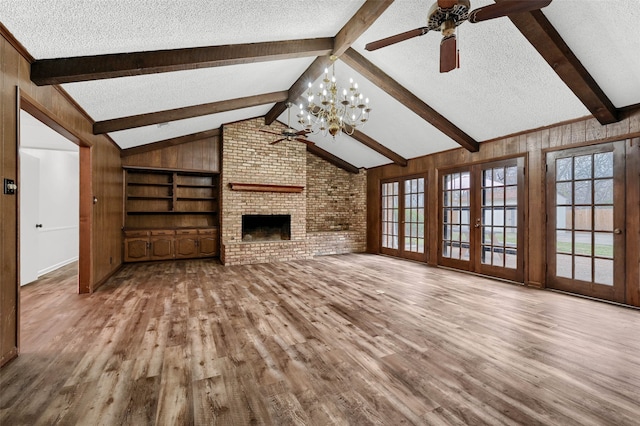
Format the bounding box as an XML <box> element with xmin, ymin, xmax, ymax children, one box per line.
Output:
<box><xmin>365</xmin><ymin>0</ymin><xmax>551</xmax><ymax>72</ymax></box>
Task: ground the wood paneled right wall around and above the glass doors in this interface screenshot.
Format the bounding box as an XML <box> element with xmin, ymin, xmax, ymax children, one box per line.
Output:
<box><xmin>367</xmin><ymin>108</ymin><xmax>640</xmax><ymax>306</ymax></box>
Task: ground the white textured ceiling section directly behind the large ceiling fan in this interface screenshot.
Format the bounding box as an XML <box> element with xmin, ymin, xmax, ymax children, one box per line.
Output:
<box><xmin>353</xmin><ymin>0</ymin><xmax>589</xmax><ymax>141</ymax></box>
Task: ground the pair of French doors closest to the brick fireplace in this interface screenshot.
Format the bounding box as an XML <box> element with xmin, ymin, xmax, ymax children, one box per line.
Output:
<box><xmin>380</xmin><ymin>176</ymin><xmax>426</xmax><ymax>260</ymax></box>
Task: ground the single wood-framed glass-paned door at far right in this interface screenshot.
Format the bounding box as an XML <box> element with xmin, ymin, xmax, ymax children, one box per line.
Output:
<box><xmin>547</xmin><ymin>142</ymin><xmax>625</xmax><ymax>302</ymax></box>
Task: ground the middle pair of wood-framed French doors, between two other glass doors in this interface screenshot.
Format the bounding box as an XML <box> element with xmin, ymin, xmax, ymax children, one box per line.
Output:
<box><xmin>438</xmin><ymin>157</ymin><xmax>524</xmax><ymax>282</ymax></box>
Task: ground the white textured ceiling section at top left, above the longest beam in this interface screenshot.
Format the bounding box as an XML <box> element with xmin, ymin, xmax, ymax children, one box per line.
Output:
<box><xmin>0</xmin><ymin>0</ymin><xmax>364</xmax><ymax>59</ymax></box>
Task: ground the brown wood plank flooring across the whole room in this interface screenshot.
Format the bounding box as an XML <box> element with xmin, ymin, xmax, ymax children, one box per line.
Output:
<box><xmin>0</xmin><ymin>254</ymin><xmax>640</xmax><ymax>425</ymax></box>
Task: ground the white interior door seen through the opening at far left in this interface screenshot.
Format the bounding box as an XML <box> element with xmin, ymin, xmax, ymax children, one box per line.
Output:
<box><xmin>18</xmin><ymin>151</ymin><xmax>40</xmax><ymax>285</ymax></box>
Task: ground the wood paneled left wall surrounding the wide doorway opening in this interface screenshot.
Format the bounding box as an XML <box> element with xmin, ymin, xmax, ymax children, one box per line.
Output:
<box><xmin>0</xmin><ymin>25</ymin><xmax>122</xmax><ymax>365</ymax></box>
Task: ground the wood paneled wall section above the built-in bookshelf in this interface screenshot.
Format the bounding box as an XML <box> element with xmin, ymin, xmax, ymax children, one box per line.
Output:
<box><xmin>122</xmin><ymin>136</ymin><xmax>220</xmax><ymax>172</ymax></box>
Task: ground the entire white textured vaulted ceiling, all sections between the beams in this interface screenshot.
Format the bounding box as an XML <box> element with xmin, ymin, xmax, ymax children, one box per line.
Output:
<box><xmin>0</xmin><ymin>0</ymin><xmax>640</xmax><ymax>167</ymax></box>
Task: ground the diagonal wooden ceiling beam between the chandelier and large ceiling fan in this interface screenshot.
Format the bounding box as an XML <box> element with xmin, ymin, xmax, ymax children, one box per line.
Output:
<box><xmin>340</xmin><ymin>49</ymin><xmax>480</xmax><ymax>152</ymax></box>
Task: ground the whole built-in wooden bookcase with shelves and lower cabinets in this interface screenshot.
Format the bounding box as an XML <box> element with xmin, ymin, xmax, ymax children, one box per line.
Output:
<box><xmin>123</xmin><ymin>166</ymin><xmax>219</xmax><ymax>262</ymax></box>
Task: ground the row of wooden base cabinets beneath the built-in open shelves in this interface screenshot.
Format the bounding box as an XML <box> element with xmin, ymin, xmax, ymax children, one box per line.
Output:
<box><xmin>124</xmin><ymin>228</ymin><xmax>219</xmax><ymax>262</ymax></box>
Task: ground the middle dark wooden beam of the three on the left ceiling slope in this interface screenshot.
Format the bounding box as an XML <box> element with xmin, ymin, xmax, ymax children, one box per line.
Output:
<box><xmin>93</xmin><ymin>91</ymin><xmax>288</xmax><ymax>135</ymax></box>
